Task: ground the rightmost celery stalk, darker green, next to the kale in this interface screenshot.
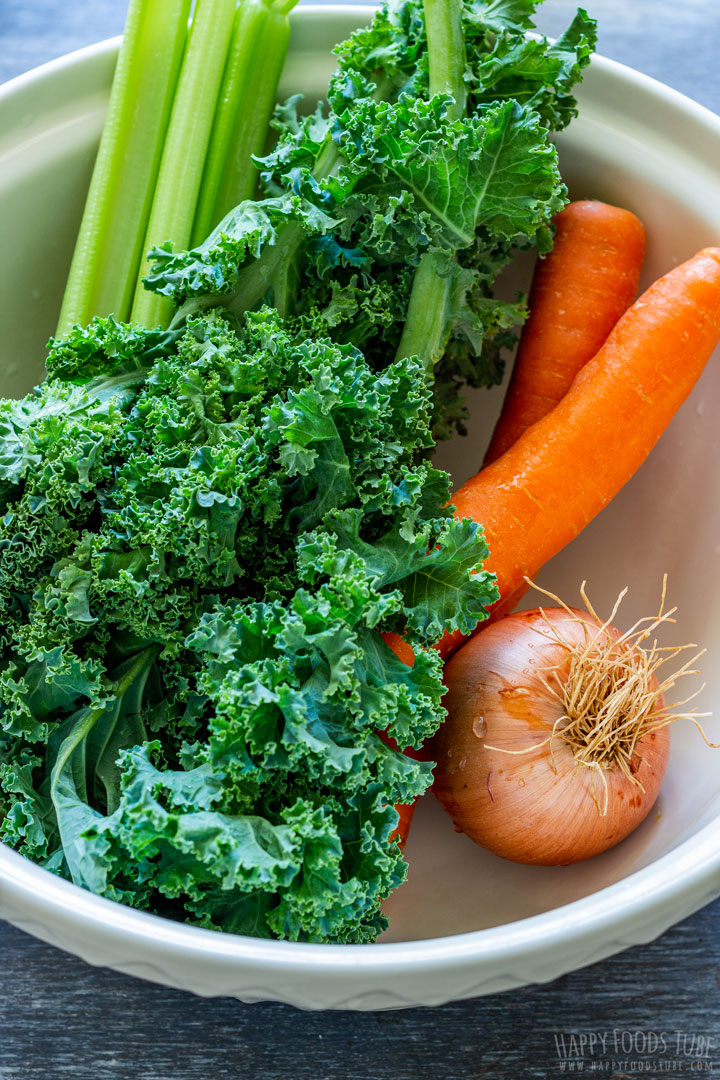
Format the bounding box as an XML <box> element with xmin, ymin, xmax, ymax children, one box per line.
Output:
<box><xmin>192</xmin><ymin>0</ymin><xmax>297</xmax><ymax>246</ymax></box>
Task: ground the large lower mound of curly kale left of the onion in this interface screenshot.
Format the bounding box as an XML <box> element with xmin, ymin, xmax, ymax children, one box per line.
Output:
<box><xmin>0</xmin><ymin>309</ymin><xmax>495</xmax><ymax>941</ymax></box>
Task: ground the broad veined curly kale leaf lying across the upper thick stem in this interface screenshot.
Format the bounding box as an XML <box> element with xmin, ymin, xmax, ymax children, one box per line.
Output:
<box><xmin>340</xmin><ymin>96</ymin><xmax>565</xmax><ymax>252</ymax></box>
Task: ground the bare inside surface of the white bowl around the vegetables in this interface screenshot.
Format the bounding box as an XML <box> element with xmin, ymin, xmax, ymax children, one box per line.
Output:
<box><xmin>0</xmin><ymin>9</ymin><xmax>720</xmax><ymax>941</ymax></box>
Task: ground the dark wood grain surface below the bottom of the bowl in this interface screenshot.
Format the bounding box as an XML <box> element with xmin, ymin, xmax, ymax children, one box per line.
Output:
<box><xmin>0</xmin><ymin>904</ymin><xmax>720</xmax><ymax>1080</ymax></box>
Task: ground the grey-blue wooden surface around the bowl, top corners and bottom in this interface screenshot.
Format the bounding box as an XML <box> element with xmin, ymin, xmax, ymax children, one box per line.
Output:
<box><xmin>0</xmin><ymin>0</ymin><xmax>720</xmax><ymax>1080</ymax></box>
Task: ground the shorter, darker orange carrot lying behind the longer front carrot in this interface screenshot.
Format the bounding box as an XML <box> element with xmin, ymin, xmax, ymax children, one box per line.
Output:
<box><xmin>485</xmin><ymin>200</ymin><xmax>646</xmax><ymax>464</ymax></box>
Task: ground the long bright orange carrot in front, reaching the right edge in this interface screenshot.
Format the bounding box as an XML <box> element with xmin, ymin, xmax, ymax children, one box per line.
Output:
<box><xmin>438</xmin><ymin>247</ymin><xmax>720</xmax><ymax>657</ymax></box>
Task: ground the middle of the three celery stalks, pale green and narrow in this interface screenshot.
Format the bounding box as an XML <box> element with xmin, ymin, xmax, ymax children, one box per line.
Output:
<box><xmin>131</xmin><ymin>0</ymin><xmax>235</xmax><ymax>327</ymax></box>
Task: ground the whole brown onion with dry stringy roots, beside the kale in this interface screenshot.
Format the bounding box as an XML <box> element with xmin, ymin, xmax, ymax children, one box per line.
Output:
<box><xmin>427</xmin><ymin>590</ymin><xmax>702</xmax><ymax>865</ymax></box>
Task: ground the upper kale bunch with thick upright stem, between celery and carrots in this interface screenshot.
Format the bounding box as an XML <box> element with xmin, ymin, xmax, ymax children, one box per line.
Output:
<box><xmin>146</xmin><ymin>0</ymin><xmax>596</xmax><ymax>438</ymax></box>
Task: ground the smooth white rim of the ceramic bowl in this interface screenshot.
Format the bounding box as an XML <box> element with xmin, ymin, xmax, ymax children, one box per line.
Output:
<box><xmin>0</xmin><ymin>3</ymin><xmax>720</xmax><ymax>977</ymax></box>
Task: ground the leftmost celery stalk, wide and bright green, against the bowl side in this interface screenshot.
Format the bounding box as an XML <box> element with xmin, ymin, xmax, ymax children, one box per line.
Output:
<box><xmin>56</xmin><ymin>0</ymin><xmax>190</xmax><ymax>337</ymax></box>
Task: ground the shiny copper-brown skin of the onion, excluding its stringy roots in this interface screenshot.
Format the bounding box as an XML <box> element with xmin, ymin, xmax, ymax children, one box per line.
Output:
<box><xmin>426</xmin><ymin>608</ymin><xmax>670</xmax><ymax>866</ymax></box>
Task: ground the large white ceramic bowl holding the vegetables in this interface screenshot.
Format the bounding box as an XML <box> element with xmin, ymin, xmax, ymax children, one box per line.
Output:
<box><xmin>0</xmin><ymin>5</ymin><xmax>720</xmax><ymax>1009</ymax></box>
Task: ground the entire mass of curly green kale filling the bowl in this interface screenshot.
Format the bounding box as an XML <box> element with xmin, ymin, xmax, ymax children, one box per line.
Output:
<box><xmin>0</xmin><ymin>0</ymin><xmax>594</xmax><ymax>942</ymax></box>
